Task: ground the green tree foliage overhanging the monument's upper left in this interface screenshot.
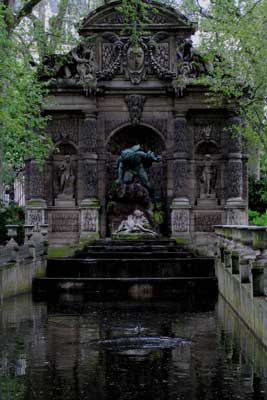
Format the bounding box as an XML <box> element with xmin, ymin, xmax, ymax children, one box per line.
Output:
<box><xmin>0</xmin><ymin>0</ymin><xmax>99</xmax><ymax>181</ymax></box>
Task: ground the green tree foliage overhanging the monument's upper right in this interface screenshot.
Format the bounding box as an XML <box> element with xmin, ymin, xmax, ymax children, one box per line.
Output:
<box><xmin>180</xmin><ymin>0</ymin><xmax>267</xmax><ymax>161</ymax></box>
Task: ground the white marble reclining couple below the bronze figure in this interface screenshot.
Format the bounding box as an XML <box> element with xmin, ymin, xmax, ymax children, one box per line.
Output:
<box><xmin>115</xmin><ymin>210</ymin><xmax>157</xmax><ymax>236</ymax></box>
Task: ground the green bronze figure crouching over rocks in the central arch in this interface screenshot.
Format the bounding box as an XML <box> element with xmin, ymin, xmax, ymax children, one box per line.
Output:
<box><xmin>117</xmin><ymin>144</ymin><xmax>161</xmax><ymax>200</ymax></box>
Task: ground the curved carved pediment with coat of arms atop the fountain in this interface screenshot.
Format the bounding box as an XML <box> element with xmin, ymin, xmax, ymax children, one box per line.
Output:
<box><xmin>43</xmin><ymin>2</ymin><xmax>209</xmax><ymax>95</ymax></box>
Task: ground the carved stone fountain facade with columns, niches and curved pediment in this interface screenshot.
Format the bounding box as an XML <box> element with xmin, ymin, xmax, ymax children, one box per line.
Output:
<box><xmin>26</xmin><ymin>2</ymin><xmax>247</xmax><ymax>246</ymax></box>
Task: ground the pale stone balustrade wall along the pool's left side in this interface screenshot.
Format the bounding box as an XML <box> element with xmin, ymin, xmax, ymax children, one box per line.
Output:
<box><xmin>0</xmin><ymin>225</ymin><xmax>48</xmax><ymax>302</ymax></box>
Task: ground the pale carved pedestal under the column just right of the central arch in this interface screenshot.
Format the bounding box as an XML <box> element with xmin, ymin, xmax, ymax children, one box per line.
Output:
<box><xmin>171</xmin><ymin>197</ymin><xmax>191</xmax><ymax>238</ymax></box>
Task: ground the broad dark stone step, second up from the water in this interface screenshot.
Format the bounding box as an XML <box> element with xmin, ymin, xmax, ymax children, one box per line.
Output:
<box><xmin>47</xmin><ymin>257</ymin><xmax>214</xmax><ymax>278</ymax></box>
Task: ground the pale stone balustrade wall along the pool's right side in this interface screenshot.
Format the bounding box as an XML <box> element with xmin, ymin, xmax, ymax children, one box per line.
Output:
<box><xmin>215</xmin><ymin>225</ymin><xmax>267</xmax><ymax>346</ymax></box>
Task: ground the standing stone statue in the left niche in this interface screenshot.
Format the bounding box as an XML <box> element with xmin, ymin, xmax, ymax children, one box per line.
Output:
<box><xmin>58</xmin><ymin>155</ymin><xmax>75</xmax><ymax>197</ymax></box>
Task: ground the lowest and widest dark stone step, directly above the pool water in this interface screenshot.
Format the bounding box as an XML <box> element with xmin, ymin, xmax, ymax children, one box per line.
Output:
<box><xmin>33</xmin><ymin>276</ymin><xmax>217</xmax><ymax>299</ymax></box>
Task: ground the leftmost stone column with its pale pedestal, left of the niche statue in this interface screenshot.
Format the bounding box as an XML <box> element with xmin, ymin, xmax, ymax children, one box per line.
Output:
<box><xmin>25</xmin><ymin>160</ymin><xmax>47</xmax><ymax>231</ymax></box>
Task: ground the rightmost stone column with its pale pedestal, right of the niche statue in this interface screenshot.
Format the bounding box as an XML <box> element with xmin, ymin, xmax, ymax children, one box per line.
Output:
<box><xmin>225</xmin><ymin>116</ymin><xmax>247</xmax><ymax>225</ymax></box>
